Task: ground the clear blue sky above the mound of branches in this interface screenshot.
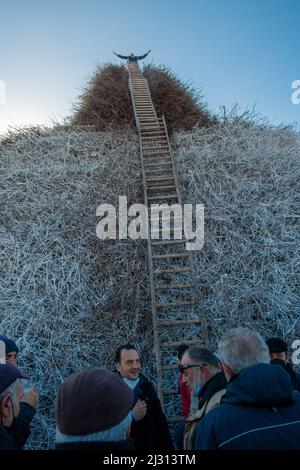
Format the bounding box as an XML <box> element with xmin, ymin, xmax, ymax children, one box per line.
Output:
<box><xmin>0</xmin><ymin>0</ymin><xmax>300</xmax><ymax>132</ymax></box>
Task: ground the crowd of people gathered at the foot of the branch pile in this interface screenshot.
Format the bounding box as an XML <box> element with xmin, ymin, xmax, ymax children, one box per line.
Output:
<box><xmin>0</xmin><ymin>328</ymin><xmax>300</xmax><ymax>452</ymax></box>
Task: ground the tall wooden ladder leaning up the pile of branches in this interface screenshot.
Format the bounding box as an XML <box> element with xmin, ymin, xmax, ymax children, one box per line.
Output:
<box><xmin>127</xmin><ymin>62</ymin><xmax>208</xmax><ymax>422</ymax></box>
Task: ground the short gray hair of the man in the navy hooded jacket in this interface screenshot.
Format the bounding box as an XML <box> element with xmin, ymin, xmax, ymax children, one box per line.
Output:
<box><xmin>218</xmin><ymin>328</ymin><xmax>270</xmax><ymax>374</ymax></box>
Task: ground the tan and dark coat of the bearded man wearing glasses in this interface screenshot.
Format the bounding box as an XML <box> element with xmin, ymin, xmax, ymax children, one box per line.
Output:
<box><xmin>183</xmin><ymin>372</ymin><xmax>227</xmax><ymax>450</ymax></box>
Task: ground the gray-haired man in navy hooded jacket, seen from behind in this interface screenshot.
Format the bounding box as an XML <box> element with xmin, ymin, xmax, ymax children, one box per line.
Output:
<box><xmin>194</xmin><ymin>328</ymin><xmax>300</xmax><ymax>450</ymax></box>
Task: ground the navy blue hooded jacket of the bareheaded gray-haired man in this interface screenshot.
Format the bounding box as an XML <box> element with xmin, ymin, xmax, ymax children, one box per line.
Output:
<box><xmin>194</xmin><ymin>364</ymin><xmax>300</xmax><ymax>450</ymax></box>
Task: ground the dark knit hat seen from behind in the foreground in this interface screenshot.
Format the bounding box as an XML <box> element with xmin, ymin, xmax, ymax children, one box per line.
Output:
<box><xmin>56</xmin><ymin>369</ymin><xmax>134</xmax><ymax>436</ymax></box>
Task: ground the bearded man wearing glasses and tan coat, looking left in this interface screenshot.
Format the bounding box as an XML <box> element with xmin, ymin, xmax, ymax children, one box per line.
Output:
<box><xmin>178</xmin><ymin>346</ymin><xmax>227</xmax><ymax>450</ymax></box>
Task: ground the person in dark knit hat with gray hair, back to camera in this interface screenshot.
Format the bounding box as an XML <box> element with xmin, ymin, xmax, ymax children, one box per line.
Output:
<box><xmin>56</xmin><ymin>369</ymin><xmax>134</xmax><ymax>452</ymax></box>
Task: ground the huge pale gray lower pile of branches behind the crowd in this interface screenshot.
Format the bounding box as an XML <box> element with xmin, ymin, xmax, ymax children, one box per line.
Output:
<box><xmin>0</xmin><ymin>117</ymin><xmax>300</xmax><ymax>449</ymax></box>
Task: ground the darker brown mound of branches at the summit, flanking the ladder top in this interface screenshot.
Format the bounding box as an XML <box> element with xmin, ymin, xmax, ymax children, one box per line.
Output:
<box><xmin>71</xmin><ymin>64</ymin><xmax>212</xmax><ymax>131</ymax></box>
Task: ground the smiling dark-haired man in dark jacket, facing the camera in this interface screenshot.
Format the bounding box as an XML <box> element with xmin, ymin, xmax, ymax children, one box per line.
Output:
<box><xmin>115</xmin><ymin>344</ymin><xmax>174</xmax><ymax>451</ymax></box>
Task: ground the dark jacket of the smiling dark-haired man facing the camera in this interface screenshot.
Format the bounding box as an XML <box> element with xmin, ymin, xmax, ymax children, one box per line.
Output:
<box><xmin>119</xmin><ymin>374</ymin><xmax>174</xmax><ymax>451</ymax></box>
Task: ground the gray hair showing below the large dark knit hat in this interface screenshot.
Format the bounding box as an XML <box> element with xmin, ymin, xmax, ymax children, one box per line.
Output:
<box><xmin>56</xmin><ymin>412</ymin><xmax>132</xmax><ymax>444</ymax></box>
